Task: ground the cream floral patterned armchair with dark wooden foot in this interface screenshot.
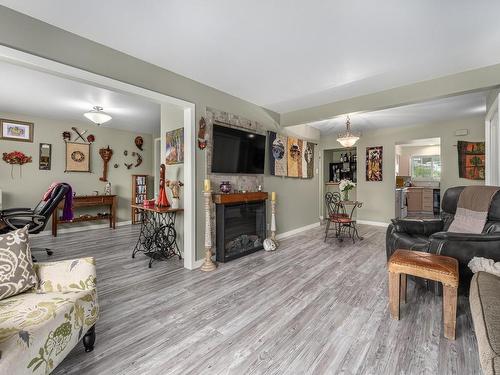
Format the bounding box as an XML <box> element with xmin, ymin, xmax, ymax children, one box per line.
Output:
<box><xmin>0</xmin><ymin>258</ymin><xmax>99</xmax><ymax>374</ymax></box>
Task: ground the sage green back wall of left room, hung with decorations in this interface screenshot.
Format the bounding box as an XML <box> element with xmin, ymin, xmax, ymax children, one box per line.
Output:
<box><xmin>0</xmin><ymin>113</ymin><xmax>152</xmax><ymax>229</ymax></box>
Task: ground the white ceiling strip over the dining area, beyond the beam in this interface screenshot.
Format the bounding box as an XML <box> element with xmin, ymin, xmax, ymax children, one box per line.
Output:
<box><xmin>308</xmin><ymin>91</ymin><xmax>487</xmax><ymax>135</ymax></box>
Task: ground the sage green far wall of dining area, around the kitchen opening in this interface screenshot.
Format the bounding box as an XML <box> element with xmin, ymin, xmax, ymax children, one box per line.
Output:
<box><xmin>320</xmin><ymin>116</ymin><xmax>484</xmax><ymax>223</ymax></box>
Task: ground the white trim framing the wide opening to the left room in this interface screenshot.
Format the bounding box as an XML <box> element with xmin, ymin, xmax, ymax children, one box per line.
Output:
<box><xmin>0</xmin><ymin>45</ymin><xmax>199</xmax><ymax>269</ymax></box>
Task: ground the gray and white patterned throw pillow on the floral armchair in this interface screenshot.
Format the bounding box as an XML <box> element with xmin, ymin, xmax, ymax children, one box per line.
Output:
<box><xmin>0</xmin><ymin>226</ymin><xmax>37</xmax><ymax>300</ymax></box>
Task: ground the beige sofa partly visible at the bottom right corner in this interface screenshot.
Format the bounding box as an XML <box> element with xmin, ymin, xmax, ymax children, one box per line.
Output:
<box><xmin>469</xmin><ymin>272</ymin><xmax>500</xmax><ymax>375</ymax></box>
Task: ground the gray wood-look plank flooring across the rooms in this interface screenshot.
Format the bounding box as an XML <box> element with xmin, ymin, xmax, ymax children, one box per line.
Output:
<box><xmin>30</xmin><ymin>226</ymin><xmax>480</xmax><ymax>374</ymax></box>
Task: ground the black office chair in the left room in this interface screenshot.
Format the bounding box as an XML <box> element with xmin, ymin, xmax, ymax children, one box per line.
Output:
<box><xmin>0</xmin><ymin>184</ymin><xmax>70</xmax><ymax>255</ymax></box>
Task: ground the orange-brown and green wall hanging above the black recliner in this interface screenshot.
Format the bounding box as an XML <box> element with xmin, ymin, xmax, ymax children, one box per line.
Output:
<box><xmin>457</xmin><ymin>141</ymin><xmax>485</xmax><ymax>180</ymax></box>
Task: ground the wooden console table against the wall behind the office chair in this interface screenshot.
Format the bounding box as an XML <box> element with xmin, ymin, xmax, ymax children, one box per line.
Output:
<box><xmin>52</xmin><ymin>195</ymin><xmax>117</xmax><ymax>237</ymax></box>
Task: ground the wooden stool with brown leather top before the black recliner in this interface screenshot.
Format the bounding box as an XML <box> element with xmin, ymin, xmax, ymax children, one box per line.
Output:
<box><xmin>388</xmin><ymin>250</ymin><xmax>458</xmax><ymax>340</ymax></box>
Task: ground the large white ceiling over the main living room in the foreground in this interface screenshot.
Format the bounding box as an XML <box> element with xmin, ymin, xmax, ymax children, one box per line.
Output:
<box><xmin>0</xmin><ymin>0</ymin><xmax>500</xmax><ymax>112</ymax></box>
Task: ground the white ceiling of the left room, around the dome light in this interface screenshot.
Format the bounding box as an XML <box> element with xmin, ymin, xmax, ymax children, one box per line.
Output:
<box><xmin>0</xmin><ymin>61</ymin><xmax>161</xmax><ymax>133</ymax></box>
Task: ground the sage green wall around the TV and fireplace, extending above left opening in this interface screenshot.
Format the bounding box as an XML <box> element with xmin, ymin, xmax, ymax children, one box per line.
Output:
<box><xmin>0</xmin><ymin>6</ymin><xmax>318</xmax><ymax>257</ymax></box>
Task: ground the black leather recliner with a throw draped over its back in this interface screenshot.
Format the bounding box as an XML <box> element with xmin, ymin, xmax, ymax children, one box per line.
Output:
<box><xmin>386</xmin><ymin>186</ymin><xmax>500</xmax><ymax>294</ymax></box>
